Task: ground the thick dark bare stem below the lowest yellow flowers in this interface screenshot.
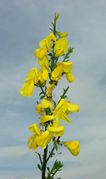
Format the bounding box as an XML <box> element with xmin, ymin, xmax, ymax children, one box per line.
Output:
<box><xmin>42</xmin><ymin>146</ymin><xmax>48</xmax><ymax>179</ymax></box>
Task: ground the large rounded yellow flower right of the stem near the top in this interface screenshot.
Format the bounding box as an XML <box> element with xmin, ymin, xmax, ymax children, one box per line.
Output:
<box><xmin>54</xmin><ymin>38</ymin><xmax>68</xmax><ymax>57</ymax></box>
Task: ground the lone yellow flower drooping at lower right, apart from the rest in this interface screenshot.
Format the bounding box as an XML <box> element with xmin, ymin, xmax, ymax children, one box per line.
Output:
<box><xmin>63</xmin><ymin>140</ymin><xmax>80</xmax><ymax>156</ymax></box>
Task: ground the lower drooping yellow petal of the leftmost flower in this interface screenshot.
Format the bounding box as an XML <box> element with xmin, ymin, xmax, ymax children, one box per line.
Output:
<box><xmin>20</xmin><ymin>80</ymin><xmax>34</xmax><ymax>96</ymax></box>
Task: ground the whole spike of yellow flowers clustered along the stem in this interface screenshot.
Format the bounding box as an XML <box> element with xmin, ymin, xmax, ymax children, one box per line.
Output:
<box><xmin>20</xmin><ymin>13</ymin><xmax>80</xmax><ymax>161</ymax></box>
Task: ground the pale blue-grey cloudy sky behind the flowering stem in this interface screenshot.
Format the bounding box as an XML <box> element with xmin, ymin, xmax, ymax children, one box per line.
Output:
<box><xmin>0</xmin><ymin>0</ymin><xmax>106</xmax><ymax>179</ymax></box>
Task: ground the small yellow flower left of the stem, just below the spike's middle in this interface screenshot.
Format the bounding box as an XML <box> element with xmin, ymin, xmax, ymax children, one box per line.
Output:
<box><xmin>36</xmin><ymin>99</ymin><xmax>53</xmax><ymax>114</ymax></box>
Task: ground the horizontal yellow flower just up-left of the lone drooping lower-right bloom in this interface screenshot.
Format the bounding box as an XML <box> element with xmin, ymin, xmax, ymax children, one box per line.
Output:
<box><xmin>47</xmin><ymin>126</ymin><xmax>64</xmax><ymax>137</ymax></box>
